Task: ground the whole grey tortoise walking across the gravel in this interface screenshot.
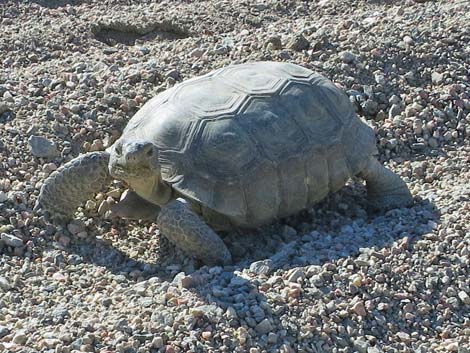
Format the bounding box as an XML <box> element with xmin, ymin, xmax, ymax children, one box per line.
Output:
<box><xmin>36</xmin><ymin>62</ymin><xmax>412</xmax><ymax>264</ymax></box>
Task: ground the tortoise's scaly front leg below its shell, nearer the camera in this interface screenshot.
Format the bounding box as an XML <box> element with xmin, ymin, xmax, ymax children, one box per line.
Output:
<box><xmin>157</xmin><ymin>199</ymin><xmax>232</xmax><ymax>265</ymax></box>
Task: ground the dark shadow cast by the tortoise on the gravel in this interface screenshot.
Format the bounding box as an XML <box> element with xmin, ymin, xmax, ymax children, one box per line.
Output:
<box><xmin>47</xmin><ymin>184</ymin><xmax>440</xmax><ymax>349</ymax></box>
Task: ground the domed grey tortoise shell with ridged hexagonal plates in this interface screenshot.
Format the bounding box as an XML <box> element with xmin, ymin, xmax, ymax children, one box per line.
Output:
<box><xmin>123</xmin><ymin>62</ymin><xmax>375</xmax><ymax>227</ymax></box>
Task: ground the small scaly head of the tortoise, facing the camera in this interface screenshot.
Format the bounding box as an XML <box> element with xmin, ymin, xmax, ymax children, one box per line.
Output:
<box><xmin>108</xmin><ymin>138</ymin><xmax>160</xmax><ymax>180</ymax></box>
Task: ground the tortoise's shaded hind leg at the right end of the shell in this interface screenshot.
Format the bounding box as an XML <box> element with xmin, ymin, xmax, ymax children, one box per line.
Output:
<box><xmin>358</xmin><ymin>157</ymin><xmax>413</xmax><ymax>210</ymax></box>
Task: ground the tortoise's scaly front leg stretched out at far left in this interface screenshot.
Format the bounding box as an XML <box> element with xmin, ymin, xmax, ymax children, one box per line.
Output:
<box><xmin>35</xmin><ymin>151</ymin><xmax>111</xmax><ymax>221</ymax></box>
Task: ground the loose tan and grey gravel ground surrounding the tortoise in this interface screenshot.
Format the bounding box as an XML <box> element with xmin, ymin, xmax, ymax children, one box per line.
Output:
<box><xmin>0</xmin><ymin>0</ymin><xmax>470</xmax><ymax>353</ymax></box>
